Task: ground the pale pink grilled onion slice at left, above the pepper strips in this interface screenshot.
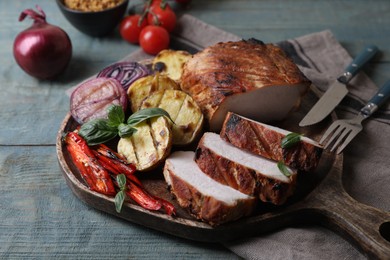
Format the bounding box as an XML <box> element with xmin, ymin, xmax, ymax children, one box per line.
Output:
<box><xmin>70</xmin><ymin>78</ymin><xmax>127</xmax><ymax>124</ymax></box>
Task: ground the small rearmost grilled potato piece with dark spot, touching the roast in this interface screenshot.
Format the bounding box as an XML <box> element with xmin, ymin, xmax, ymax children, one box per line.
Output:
<box><xmin>153</xmin><ymin>50</ymin><xmax>192</xmax><ymax>82</ymax></box>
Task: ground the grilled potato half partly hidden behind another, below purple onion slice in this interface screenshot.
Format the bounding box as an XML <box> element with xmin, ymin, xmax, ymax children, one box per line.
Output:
<box><xmin>127</xmin><ymin>73</ymin><xmax>180</xmax><ymax>113</ymax></box>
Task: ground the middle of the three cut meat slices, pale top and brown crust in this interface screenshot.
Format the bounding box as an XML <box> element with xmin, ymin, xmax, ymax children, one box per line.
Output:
<box><xmin>195</xmin><ymin>132</ymin><xmax>296</xmax><ymax>205</ymax></box>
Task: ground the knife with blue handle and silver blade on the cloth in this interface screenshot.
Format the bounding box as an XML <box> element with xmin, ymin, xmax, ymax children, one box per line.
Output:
<box><xmin>299</xmin><ymin>45</ymin><xmax>378</xmax><ymax>126</ymax></box>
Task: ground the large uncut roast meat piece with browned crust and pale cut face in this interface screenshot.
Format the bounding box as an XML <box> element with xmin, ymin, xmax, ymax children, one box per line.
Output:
<box><xmin>181</xmin><ymin>39</ymin><xmax>311</xmax><ymax>131</ymax></box>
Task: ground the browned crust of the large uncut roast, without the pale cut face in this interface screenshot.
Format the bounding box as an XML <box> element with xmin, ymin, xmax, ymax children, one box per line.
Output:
<box><xmin>181</xmin><ymin>40</ymin><xmax>310</xmax><ymax>124</ymax></box>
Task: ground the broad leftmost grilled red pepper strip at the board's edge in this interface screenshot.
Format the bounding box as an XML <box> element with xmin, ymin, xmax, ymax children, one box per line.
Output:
<box><xmin>64</xmin><ymin>132</ymin><xmax>116</xmax><ymax>196</ymax></box>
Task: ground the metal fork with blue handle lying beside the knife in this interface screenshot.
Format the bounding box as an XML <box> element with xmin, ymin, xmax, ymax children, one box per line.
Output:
<box><xmin>320</xmin><ymin>80</ymin><xmax>390</xmax><ymax>154</ymax></box>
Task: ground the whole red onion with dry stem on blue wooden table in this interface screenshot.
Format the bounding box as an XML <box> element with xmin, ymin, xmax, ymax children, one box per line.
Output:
<box><xmin>14</xmin><ymin>6</ymin><xmax>72</xmax><ymax>79</ymax></box>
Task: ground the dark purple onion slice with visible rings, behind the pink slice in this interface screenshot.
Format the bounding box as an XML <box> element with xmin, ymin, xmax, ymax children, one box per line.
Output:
<box><xmin>97</xmin><ymin>61</ymin><xmax>150</xmax><ymax>90</ymax></box>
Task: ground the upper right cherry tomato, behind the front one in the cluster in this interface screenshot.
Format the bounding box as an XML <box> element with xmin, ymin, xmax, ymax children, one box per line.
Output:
<box><xmin>148</xmin><ymin>3</ymin><xmax>176</xmax><ymax>32</ymax></box>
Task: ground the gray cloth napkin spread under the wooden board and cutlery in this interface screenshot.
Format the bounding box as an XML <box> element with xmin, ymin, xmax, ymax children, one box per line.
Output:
<box><xmin>117</xmin><ymin>15</ymin><xmax>390</xmax><ymax>259</ymax></box>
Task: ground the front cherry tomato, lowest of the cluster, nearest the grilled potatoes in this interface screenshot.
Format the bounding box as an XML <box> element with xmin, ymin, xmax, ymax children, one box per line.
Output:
<box><xmin>139</xmin><ymin>25</ymin><xmax>169</xmax><ymax>55</ymax></box>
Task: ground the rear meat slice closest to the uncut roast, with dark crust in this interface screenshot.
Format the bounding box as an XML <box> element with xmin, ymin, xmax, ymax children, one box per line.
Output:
<box><xmin>220</xmin><ymin>112</ymin><xmax>323</xmax><ymax>172</ymax></box>
